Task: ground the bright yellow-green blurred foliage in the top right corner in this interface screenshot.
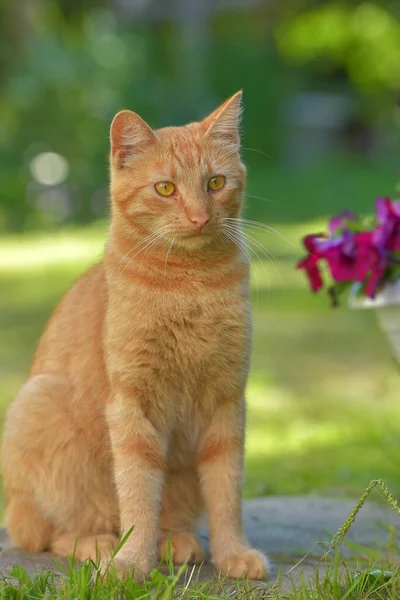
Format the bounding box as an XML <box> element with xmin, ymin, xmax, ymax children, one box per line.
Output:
<box><xmin>276</xmin><ymin>0</ymin><xmax>400</xmax><ymax>92</ymax></box>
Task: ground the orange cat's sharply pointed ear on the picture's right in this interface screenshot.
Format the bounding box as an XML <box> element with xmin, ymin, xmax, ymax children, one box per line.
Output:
<box><xmin>202</xmin><ymin>90</ymin><xmax>243</xmax><ymax>152</ymax></box>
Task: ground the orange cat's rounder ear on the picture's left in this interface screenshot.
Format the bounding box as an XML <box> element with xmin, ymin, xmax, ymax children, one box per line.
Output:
<box><xmin>110</xmin><ymin>110</ymin><xmax>157</xmax><ymax>169</ymax></box>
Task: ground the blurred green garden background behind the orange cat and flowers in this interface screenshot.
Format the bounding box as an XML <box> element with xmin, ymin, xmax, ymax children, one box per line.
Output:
<box><xmin>0</xmin><ymin>0</ymin><xmax>400</xmax><ymax>516</ymax></box>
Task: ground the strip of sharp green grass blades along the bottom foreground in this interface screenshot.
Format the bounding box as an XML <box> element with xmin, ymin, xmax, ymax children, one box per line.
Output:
<box><xmin>0</xmin><ymin>561</ymin><xmax>400</xmax><ymax>600</ymax></box>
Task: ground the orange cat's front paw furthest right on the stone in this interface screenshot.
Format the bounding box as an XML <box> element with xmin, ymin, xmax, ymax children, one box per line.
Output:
<box><xmin>214</xmin><ymin>548</ymin><xmax>269</xmax><ymax>580</ymax></box>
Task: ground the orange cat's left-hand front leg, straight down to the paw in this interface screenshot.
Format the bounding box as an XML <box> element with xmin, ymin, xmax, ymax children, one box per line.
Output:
<box><xmin>106</xmin><ymin>389</ymin><xmax>167</xmax><ymax>581</ymax></box>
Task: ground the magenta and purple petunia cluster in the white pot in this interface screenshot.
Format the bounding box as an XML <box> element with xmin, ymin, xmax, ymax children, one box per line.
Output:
<box><xmin>297</xmin><ymin>198</ymin><xmax>400</xmax><ymax>303</ymax></box>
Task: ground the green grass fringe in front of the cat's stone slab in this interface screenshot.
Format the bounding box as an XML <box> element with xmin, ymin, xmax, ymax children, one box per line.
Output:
<box><xmin>0</xmin><ymin>547</ymin><xmax>400</xmax><ymax>600</ymax></box>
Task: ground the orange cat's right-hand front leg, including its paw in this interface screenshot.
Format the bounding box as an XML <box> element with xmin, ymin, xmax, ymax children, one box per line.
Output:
<box><xmin>198</xmin><ymin>398</ymin><xmax>268</xmax><ymax>579</ymax></box>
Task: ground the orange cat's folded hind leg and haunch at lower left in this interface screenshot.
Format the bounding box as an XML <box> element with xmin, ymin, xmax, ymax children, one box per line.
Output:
<box><xmin>2</xmin><ymin>374</ymin><xmax>118</xmax><ymax>558</ymax></box>
